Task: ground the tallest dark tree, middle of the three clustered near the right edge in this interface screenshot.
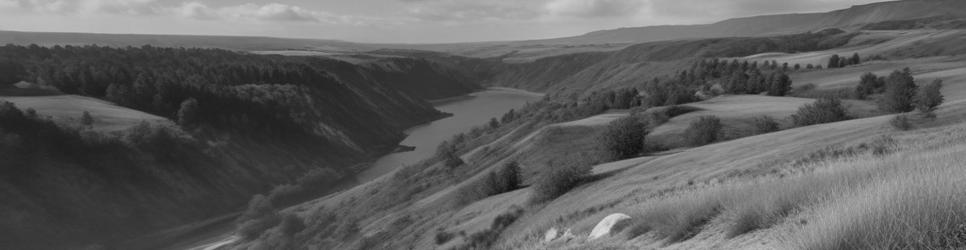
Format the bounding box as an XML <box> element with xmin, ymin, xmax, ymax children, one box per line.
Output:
<box><xmin>879</xmin><ymin>68</ymin><xmax>918</xmax><ymax>113</ymax></box>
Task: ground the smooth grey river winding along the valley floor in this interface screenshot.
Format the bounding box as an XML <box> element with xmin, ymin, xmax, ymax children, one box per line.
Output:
<box><xmin>357</xmin><ymin>88</ymin><xmax>543</xmax><ymax>183</ymax></box>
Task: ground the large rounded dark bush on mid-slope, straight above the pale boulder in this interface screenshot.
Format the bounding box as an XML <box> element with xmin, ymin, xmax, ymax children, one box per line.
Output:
<box><xmin>597</xmin><ymin>117</ymin><xmax>647</xmax><ymax>159</ymax></box>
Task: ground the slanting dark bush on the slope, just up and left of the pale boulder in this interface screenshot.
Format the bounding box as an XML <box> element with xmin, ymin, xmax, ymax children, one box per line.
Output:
<box><xmin>531</xmin><ymin>157</ymin><xmax>591</xmax><ymax>202</ymax></box>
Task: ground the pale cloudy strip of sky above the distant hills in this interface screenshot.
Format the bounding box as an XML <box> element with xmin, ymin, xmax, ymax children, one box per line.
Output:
<box><xmin>0</xmin><ymin>0</ymin><xmax>882</xmax><ymax>43</ymax></box>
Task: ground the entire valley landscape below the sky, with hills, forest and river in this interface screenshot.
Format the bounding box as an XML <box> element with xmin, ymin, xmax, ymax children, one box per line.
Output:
<box><xmin>0</xmin><ymin>0</ymin><xmax>966</xmax><ymax>250</ymax></box>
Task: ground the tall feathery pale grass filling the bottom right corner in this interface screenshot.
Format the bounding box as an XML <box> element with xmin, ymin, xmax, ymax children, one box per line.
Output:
<box><xmin>792</xmin><ymin>145</ymin><xmax>966</xmax><ymax>249</ymax></box>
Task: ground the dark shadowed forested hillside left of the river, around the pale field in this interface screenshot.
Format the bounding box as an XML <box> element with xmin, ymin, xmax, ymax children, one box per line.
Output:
<box><xmin>0</xmin><ymin>45</ymin><xmax>480</xmax><ymax>249</ymax></box>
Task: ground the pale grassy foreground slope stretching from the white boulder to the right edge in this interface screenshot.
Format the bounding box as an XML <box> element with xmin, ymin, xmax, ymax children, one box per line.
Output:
<box><xmin>625</xmin><ymin>122</ymin><xmax>966</xmax><ymax>250</ymax></box>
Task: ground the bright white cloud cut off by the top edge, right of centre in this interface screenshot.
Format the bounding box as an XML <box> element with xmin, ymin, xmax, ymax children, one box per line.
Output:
<box><xmin>546</xmin><ymin>0</ymin><xmax>646</xmax><ymax>18</ymax></box>
